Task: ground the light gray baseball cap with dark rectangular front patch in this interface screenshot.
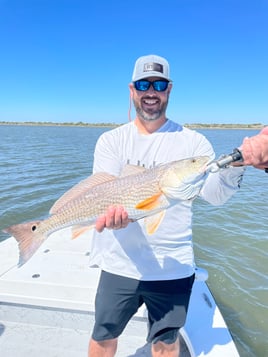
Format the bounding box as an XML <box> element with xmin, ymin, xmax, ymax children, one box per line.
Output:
<box><xmin>132</xmin><ymin>55</ymin><xmax>171</xmax><ymax>82</ymax></box>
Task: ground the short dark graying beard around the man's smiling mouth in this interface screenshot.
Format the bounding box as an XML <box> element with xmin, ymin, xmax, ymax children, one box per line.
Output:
<box><xmin>133</xmin><ymin>97</ymin><xmax>168</xmax><ymax>121</ymax></box>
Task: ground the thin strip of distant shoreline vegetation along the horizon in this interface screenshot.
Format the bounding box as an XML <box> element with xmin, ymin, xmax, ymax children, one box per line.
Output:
<box><xmin>0</xmin><ymin>121</ymin><xmax>266</xmax><ymax>129</ymax></box>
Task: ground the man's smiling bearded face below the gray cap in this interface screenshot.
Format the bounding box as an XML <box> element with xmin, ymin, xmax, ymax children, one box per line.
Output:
<box><xmin>129</xmin><ymin>77</ymin><xmax>172</xmax><ymax>121</ymax></box>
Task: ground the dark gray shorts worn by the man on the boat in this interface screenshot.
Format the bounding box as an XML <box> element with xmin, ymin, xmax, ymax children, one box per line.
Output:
<box><xmin>92</xmin><ymin>271</ymin><xmax>194</xmax><ymax>343</ymax></box>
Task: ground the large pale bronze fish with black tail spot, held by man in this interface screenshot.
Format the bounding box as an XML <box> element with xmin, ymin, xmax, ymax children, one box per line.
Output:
<box><xmin>3</xmin><ymin>156</ymin><xmax>210</xmax><ymax>266</ymax></box>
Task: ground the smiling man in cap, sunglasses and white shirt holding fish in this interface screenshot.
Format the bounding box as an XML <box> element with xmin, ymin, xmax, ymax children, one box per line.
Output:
<box><xmin>89</xmin><ymin>55</ymin><xmax>245</xmax><ymax>357</ymax></box>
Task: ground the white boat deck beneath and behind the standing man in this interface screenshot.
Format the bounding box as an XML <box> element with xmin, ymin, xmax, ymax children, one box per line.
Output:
<box><xmin>0</xmin><ymin>230</ymin><xmax>239</xmax><ymax>357</ymax></box>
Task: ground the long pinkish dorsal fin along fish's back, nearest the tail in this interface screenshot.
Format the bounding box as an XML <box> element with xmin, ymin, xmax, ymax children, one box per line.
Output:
<box><xmin>49</xmin><ymin>172</ymin><xmax>116</xmax><ymax>214</ymax></box>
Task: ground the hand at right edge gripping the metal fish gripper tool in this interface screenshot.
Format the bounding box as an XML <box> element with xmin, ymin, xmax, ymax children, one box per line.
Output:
<box><xmin>240</xmin><ymin>127</ymin><xmax>268</xmax><ymax>169</ymax></box>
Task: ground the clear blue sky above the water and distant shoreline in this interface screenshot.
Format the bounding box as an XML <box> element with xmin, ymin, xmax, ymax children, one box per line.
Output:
<box><xmin>0</xmin><ymin>0</ymin><xmax>268</xmax><ymax>124</ymax></box>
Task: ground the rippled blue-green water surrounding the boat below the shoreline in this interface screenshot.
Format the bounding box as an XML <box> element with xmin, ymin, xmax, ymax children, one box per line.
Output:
<box><xmin>0</xmin><ymin>126</ymin><xmax>268</xmax><ymax>357</ymax></box>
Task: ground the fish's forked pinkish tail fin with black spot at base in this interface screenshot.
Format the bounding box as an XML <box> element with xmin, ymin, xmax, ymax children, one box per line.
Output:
<box><xmin>3</xmin><ymin>221</ymin><xmax>46</xmax><ymax>266</ymax></box>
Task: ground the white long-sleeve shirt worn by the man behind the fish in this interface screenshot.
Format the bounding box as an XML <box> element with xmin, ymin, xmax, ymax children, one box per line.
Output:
<box><xmin>90</xmin><ymin>120</ymin><xmax>244</xmax><ymax>280</ymax></box>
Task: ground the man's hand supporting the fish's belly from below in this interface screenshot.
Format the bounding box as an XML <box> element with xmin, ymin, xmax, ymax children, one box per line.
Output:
<box><xmin>95</xmin><ymin>206</ymin><xmax>131</xmax><ymax>233</ymax></box>
